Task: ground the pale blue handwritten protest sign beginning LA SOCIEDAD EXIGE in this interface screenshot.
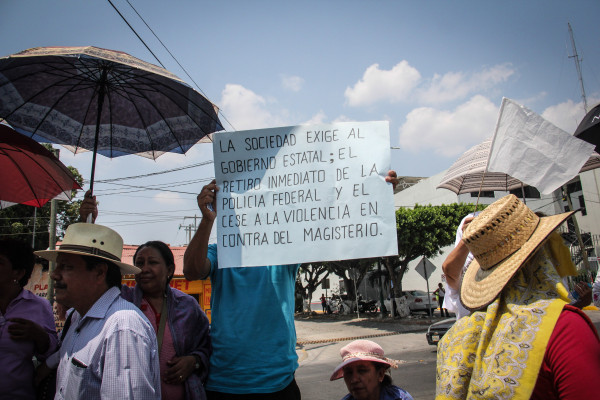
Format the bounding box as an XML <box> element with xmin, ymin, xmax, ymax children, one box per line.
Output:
<box><xmin>213</xmin><ymin>122</ymin><xmax>398</xmax><ymax>268</ymax></box>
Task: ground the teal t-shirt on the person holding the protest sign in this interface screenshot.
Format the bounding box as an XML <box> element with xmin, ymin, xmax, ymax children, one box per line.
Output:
<box><xmin>206</xmin><ymin>244</ymin><xmax>300</xmax><ymax>394</ymax></box>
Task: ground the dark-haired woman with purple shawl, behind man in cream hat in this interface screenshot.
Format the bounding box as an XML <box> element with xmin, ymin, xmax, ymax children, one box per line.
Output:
<box><xmin>121</xmin><ymin>240</ymin><xmax>212</xmax><ymax>400</ymax></box>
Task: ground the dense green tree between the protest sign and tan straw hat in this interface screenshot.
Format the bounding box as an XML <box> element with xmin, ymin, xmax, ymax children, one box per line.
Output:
<box><xmin>384</xmin><ymin>203</ymin><xmax>485</xmax><ymax>297</ymax></box>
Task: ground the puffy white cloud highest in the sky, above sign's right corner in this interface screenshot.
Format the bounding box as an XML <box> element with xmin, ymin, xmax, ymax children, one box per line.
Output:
<box><xmin>344</xmin><ymin>60</ymin><xmax>421</xmax><ymax>107</ymax></box>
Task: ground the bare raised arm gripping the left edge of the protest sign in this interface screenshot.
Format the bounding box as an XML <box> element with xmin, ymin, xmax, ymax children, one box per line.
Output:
<box><xmin>183</xmin><ymin>179</ymin><xmax>219</xmax><ymax>281</ymax></box>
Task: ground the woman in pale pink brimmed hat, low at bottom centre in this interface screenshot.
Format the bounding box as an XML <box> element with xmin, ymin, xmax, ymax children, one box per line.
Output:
<box><xmin>330</xmin><ymin>340</ymin><xmax>412</xmax><ymax>400</ymax></box>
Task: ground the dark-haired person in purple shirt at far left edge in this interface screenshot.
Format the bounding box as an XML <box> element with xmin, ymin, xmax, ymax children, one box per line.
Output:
<box><xmin>0</xmin><ymin>239</ymin><xmax>57</xmax><ymax>400</ymax></box>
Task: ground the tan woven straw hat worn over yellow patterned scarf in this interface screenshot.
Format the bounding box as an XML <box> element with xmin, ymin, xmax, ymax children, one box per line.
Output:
<box><xmin>460</xmin><ymin>194</ymin><xmax>574</xmax><ymax>311</ymax></box>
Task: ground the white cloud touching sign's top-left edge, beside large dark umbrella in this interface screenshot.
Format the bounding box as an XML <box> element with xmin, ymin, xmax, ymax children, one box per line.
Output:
<box><xmin>219</xmin><ymin>83</ymin><xmax>285</xmax><ymax>130</ymax></box>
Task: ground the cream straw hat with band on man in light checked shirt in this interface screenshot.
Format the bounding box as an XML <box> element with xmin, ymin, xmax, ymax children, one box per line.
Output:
<box><xmin>35</xmin><ymin>222</ymin><xmax>141</xmax><ymax>275</ymax></box>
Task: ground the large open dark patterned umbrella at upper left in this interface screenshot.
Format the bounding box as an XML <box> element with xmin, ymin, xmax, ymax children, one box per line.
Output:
<box><xmin>0</xmin><ymin>47</ymin><xmax>223</xmax><ymax>191</ymax></box>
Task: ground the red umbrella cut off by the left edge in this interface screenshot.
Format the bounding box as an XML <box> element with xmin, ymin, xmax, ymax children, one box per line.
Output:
<box><xmin>0</xmin><ymin>124</ymin><xmax>81</xmax><ymax>207</ymax></box>
